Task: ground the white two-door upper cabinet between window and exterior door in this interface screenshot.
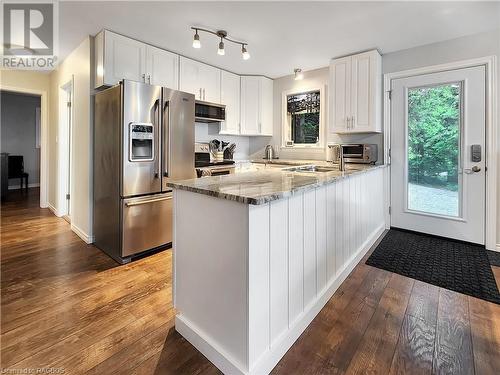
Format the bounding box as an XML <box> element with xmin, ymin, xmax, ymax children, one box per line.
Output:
<box><xmin>329</xmin><ymin>50</ymin><xmax>382</xmax><ymax>134</ymax></box>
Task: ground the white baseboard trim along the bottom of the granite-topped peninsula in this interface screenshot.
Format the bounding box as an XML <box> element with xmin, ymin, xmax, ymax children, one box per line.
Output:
<box><xmin>175</xmin><ymin>222</ymin><xmax>385</xmax><ymax>375</ymax></box>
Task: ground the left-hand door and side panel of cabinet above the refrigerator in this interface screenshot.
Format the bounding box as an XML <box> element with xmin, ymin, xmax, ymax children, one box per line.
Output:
<box><xmin>95</xmin><ymin>30</ymin><xmax>146</xmax><ymax>87</ymax></box>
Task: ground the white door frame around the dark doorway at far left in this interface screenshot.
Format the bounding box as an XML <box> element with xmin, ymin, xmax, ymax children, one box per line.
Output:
<box><xmin>0</xmin><ymin>83</ymin><xmax>49</xmax><ymax>208</ymax></box>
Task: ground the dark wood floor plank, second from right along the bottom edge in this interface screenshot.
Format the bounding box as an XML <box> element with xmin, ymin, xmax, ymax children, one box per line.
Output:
<box><xmin>433</xmin><ymin>288</ymin><xmax>474</xmax><ymax>375</ymax></box>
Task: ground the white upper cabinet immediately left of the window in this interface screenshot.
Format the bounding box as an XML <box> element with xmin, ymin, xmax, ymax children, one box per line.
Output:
<box><xmin>241</xmin><ymin>76</ymin><xmax>273</xmax><ymax>136</ymax></box>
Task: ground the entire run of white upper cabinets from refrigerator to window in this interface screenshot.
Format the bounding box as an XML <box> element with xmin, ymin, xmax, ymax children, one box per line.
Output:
<box><xmin>94</xmin><ymin>30</ymin><xmax>274</xmax><ymax>136</ymax></box>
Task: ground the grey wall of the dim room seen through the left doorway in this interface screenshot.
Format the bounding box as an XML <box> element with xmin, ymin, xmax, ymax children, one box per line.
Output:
<box><xmin>0</xmin><ymin>91</ymin><xmax>41</xmax><ymax>187</ymax></box>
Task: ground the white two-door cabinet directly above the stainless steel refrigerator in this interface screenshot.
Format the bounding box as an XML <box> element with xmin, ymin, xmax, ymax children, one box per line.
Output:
<box><xmin>95</xmin><ymin>30</ymin><xmax>179</xmax><ymax>89</ymax></box>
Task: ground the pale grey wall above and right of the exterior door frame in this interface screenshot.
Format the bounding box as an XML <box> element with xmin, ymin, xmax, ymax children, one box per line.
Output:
<box><xmin>382</xmin><ymin>29</ymin><xmax>500</xmax><ymax>244</ymax></box>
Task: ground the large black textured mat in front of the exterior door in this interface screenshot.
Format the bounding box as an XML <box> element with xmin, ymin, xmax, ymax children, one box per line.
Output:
<box><xmin>366</xmin><ymin>229</ymin><xmax>500</xmax><ymax>304</ymax></box>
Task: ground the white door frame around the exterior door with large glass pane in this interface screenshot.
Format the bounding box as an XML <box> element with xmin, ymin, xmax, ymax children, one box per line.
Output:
<box><xmin>384</xmin><ymin>55</ymin><xmax>500</xmax><ymax>251</ymax></box>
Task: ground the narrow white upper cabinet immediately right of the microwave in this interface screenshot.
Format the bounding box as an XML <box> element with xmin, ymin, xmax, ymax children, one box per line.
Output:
<box><xmin>219</xmin><ymin>70</ymin><xmax>240</xmax><ymax>135</ymax></box>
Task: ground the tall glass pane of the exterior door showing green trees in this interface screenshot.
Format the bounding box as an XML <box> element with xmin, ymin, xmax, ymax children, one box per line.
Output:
<box><xmin>407</xmin><ymin>83</ymin><xmax>461</xmax><ymax>217</ymax></box>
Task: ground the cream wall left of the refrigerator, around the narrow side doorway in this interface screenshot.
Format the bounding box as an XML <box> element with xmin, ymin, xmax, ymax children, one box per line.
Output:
<box><xmin>49</xmin><ymin>37</ymin><xmax>93</xmax><ymax>241</ymax></box>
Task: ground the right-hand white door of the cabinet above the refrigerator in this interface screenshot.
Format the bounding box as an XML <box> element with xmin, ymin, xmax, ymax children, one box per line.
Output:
<box><xmin>146</xmin><ymin>46</ymin><xmax>179</xmax><ymax>90</ymax></box>
